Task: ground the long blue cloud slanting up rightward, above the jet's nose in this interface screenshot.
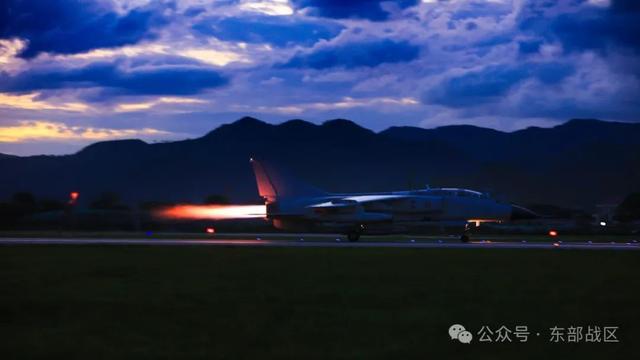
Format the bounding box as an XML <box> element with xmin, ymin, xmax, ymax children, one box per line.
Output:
<box><xmin>423</xmin><ymin>63</ymin><xmax>575</xmax><ymax>107</ymax></box>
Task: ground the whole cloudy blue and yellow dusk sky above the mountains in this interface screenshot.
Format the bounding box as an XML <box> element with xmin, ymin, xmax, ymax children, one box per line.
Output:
<box><xmin>0</xmin><ymin>0</ymin><xmax>640</xmax><ymax>155</ymax></box>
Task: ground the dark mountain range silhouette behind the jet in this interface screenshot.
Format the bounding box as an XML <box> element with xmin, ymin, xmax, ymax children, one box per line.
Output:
<box><xmin>0</xmin><ymin>117</ymin><xmax>640</xmax><ymax>207</ymax></box>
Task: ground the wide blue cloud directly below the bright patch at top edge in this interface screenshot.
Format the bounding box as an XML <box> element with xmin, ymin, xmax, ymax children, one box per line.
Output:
<box><xmin>193</xmin><ymin>16</ymin><xmax>344</xmax><ymax>47</ymax></box>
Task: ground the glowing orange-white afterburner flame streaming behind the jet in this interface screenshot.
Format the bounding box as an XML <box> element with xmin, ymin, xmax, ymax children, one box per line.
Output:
<box><xmin>156</xmin><ymin>205</ymin><xmax>266</xmax><ymax>220</ymax></box>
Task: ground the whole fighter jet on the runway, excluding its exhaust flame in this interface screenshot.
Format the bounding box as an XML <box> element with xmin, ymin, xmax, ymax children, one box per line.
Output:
<box><xmin>251</xmin><ymin>158</ymin><xmax>537</xmax><ymax>242</ymax></box>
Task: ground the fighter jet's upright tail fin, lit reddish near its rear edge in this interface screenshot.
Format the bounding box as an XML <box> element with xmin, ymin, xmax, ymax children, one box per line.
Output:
<box><xmin>251</xmin><ymin>158</ymin><xmax>327</xmax><ymax>201</ymax></box>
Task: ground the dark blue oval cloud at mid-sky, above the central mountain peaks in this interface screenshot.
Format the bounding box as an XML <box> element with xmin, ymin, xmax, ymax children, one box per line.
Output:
<box><xmin>283</xmin><ymin>40</ymin><xmax>420</xmax><ymax>69</ymax></box>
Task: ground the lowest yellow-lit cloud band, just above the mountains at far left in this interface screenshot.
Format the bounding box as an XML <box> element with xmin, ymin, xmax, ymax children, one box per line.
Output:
<box><xmin>0</xmin><ymin>120</ymin><xmax>170</xmax><ymax>143</ymax></box>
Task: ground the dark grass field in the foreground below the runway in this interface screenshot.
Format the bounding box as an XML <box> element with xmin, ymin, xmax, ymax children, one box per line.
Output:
<box><xmin>0</xmin><ymin>246</ymin><xmax>640</xmax><ymax>359</ymax></box>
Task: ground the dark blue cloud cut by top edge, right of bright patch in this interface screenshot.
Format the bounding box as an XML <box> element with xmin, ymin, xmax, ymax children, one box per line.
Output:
<box><xmin>291</xmin><ymin>0</ymin><xmax>419</xmax><ymax>21</ymax></box>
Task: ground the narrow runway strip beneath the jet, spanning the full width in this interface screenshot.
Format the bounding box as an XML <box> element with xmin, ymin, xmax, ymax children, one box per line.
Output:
<box><xmin>0</xmin><ymin>238</ymin><xmax>640</xmax><ymax>251</ymax></box>
